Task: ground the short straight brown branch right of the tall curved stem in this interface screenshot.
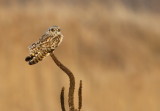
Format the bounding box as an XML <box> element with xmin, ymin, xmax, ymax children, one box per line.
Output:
<box><xmin>78</xmin><ymin>80</ymin><xmax>82</xmax><ymax>111</ymax></box>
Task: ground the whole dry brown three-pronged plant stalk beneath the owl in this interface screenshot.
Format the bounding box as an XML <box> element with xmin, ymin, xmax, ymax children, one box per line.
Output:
<box><xmin>50</xmin><ymin>53</ymin><xmax>82</xmax><ymax>111</ymax></box>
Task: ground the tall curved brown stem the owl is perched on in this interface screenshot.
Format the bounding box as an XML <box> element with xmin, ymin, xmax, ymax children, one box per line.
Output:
<box><xmin>50</xmin><ymin>53</ymin><xmax>75</xmax><ymax>111</ymax></box>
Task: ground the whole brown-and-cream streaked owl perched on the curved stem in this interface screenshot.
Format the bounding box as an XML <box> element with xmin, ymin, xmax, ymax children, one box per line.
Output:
<box><xmin>25</xmin><ymin>26</ymin><xmax>63</xmax><ymax>65</ymax></box>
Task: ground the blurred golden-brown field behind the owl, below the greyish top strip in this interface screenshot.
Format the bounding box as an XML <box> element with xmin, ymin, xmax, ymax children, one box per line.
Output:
<box><xmin>0</xmin><ymin>2</ymin><xmax>160</xmax><ymax>111</ymax></box>
